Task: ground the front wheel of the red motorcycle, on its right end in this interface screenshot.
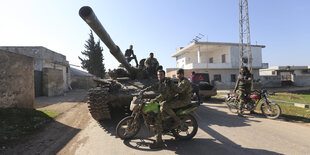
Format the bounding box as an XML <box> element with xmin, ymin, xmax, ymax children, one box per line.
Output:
<box><xmin>260</xmin><ymin>100</ymin><xmax>282</xmax><ymax>119</ymax></box>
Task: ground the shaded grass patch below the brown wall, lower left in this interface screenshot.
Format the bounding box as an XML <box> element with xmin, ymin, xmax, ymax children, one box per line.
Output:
<box><xmin>0</xmin><ymin>108</ymin><xmax>58</xmax><ymax>147</ymax></box>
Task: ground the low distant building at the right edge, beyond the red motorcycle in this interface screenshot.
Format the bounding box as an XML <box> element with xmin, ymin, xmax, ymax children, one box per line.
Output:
<box><xmin>259</xmin><ymin>66</ymin><xmax>310</xmax><ymax>87</ymax></box>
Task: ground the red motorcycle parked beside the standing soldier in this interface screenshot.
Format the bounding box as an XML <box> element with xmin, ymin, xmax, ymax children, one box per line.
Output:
<box><xmin>225</xmin><ymin>89</ymin><xmax>281</xmax><ymax>119</ymax></box>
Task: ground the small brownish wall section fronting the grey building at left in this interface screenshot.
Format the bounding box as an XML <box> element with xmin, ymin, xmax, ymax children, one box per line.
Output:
<box><xmin>43</xmin><ymin>68</ymin><xmax>64</xmax><ymax>96</ymax></box>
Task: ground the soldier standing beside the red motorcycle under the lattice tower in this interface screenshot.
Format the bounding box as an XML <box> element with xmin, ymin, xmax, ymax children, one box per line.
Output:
<box><xmin>234</xmin><ymin>66</ymin><xmax>253</xmax><ymax>116</ymax></box>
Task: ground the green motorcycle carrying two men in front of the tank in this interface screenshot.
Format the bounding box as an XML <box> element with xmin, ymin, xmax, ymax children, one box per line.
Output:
<box><xmin>116</xmin><ymin>94</ymin><xmax>200</xmax><ymax>140</ymax></box>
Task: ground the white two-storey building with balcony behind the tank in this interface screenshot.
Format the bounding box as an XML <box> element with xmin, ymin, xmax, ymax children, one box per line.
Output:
<box><xmin>167</xmin><ymin>42</ymin><xmax>268</xmax><ymax>89</ymax></box>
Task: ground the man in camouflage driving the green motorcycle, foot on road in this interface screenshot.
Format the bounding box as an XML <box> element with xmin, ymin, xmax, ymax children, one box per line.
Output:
<box><xmin>140</xmin><ymin>70</ymin><xmax>176</xmax><ymax>149</ymax></box>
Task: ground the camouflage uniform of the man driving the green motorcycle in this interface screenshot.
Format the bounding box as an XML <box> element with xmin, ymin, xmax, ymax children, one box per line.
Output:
<box><xmin>143</xmin><ymin>78</ymin><xmax>176</xmax><ymax>141</ymax></box>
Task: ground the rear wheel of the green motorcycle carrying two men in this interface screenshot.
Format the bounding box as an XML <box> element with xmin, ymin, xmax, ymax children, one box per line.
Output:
<box><xmin>172</xmin><ymin>114</ymin><xmax>198</xmax><ymax>140</ymax></box>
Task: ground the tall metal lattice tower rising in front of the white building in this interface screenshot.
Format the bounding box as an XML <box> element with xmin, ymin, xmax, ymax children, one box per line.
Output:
<box><xmin>239</xmin><ymin>0</ymin><xmax>253</xmax><ymax>89</ymax></box>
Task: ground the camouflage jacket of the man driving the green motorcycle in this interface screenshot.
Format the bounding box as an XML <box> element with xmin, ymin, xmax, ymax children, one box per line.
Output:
<box><xmin>144</xmin><ymin>78</ymin><xmax>176</xmax><ymax>102</ymax></box>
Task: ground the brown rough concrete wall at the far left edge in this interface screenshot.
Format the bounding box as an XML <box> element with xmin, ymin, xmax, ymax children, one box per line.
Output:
<box><xmin>0</xmin><ymin>50</ymin><xmax>34</xmax><ymax>108</ymax></box>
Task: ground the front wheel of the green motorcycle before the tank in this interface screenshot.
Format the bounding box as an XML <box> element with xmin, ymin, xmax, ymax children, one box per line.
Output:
<box><xmin>116</xmin><ymin>116</ymin><xmax>141</xmax><ymax>139</ymax></box>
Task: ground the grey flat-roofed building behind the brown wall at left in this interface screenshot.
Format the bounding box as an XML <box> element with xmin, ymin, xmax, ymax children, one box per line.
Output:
<box><xmin>0</xmin><ymin>46</ymin><xmax>70</xmax><ymax>97</ymax></box>
